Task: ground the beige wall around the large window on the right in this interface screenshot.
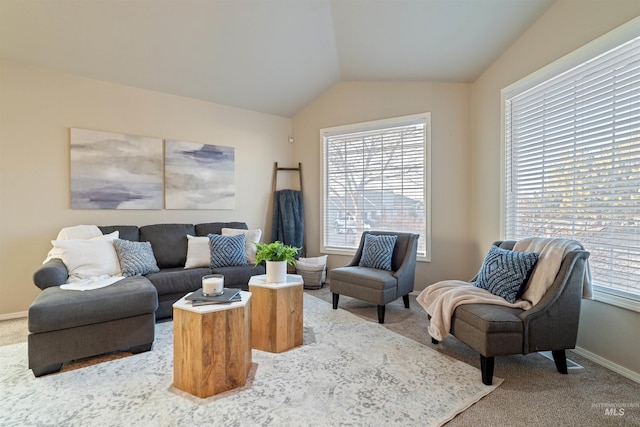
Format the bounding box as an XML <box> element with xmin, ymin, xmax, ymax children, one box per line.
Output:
<box><xmin>471</xmin><ymin>0</ymin><xmax>640</xmax><ymax>375</ymax></box>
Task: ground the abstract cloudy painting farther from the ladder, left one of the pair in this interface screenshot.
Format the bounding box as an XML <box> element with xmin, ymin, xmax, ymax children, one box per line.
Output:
<box><xmin>70</xmin><ymin>128</ymin><xmax>163</xmax><ymax>209</ymax></box>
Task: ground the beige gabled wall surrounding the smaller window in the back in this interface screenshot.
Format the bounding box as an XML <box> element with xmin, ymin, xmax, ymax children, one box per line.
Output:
<box><xmin>293</xmin><ymin>82</ymin><xmax>476</xmax><ymax>290</ymax></box>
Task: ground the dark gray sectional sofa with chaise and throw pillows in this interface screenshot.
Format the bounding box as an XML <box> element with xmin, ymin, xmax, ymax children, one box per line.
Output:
<box><xmin>28</xmin><ymin>222</ymin><xmax>265</xmax><ymax>376</ymax></box>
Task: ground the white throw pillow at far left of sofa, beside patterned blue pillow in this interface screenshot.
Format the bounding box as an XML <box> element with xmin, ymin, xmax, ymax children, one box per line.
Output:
<box><xmin>51</xmin><ymin>238</ymin><xmax>120</xmax><ymax>283</ymax></box>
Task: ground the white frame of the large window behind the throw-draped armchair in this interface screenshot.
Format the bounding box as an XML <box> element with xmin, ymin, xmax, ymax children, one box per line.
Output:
<box><xmin>500</xmin><ymin>17</ymin><xmax>640</xmax><ymax>312</ymax></box>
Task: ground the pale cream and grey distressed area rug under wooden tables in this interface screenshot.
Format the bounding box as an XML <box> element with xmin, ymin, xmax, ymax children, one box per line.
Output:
<box><xmin>0</xmin><ymin>294</ymin><xmax>502</xmax><ymax>426</ymax></box>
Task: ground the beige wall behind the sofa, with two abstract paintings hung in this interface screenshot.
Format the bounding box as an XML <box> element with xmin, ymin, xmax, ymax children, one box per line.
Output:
<box><xmin>0</xmin><ymin>62</ymin><xmax>291</xmax><ymax>318</ymax></box>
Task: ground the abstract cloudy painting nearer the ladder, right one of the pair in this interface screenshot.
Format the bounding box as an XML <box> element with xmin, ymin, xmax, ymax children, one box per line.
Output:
<box><xmin>164</xmin><ymin>140</ymin><xmax>236</xmax><ymax>209</ymax></box>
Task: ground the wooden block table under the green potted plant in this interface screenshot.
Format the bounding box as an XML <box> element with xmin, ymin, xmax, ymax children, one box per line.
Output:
<box><xmin>249</xmin><ymin>274</ymin><xmax>304</xmax><ymax>353</ymax></box>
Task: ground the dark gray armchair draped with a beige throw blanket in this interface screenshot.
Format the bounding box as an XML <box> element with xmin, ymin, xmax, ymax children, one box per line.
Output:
<box><xmin>431</xmin><ymin>241</ymin><xmax>589</xmax><ymax>385</ymax></box>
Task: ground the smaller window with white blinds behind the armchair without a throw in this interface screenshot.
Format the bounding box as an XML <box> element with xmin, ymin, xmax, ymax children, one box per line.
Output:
<box><xmin>320</xmin><ymin>113</ymin><xmax>430</xmax><ymax>261</ymax></box>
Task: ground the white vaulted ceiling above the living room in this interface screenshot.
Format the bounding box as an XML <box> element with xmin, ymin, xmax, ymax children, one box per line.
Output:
<box><xmin>0</xmin><ymin>0</ymin><xmax>555</xmax><ymax>117</ymax></box>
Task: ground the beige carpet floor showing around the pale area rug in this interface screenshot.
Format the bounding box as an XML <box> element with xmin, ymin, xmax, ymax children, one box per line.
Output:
<box><xmin>0</xmin><ymin>286</ymin><xmax>640</xmax><ymax>427</ymax></box>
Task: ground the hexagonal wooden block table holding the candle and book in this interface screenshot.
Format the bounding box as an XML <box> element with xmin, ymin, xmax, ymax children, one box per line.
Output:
<box><xmin>173</xmin><ymin>292</ymin><xmax>251</xmax><ymax>398</ymax></box>
